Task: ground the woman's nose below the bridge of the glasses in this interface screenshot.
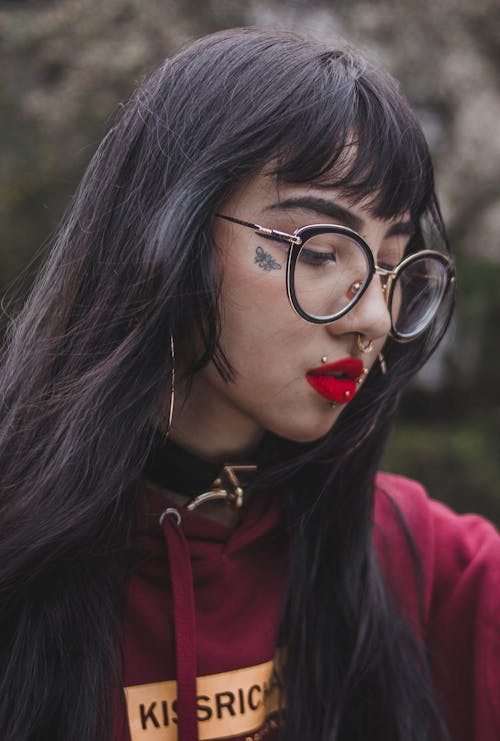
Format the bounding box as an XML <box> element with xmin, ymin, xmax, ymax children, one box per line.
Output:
<box><xmin>326</xmin><ymin>274</ymin><xmax>391</xmax><ymax>340</ymax></box>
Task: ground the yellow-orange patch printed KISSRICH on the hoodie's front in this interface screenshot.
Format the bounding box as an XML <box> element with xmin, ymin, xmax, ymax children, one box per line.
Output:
<box><xmin>125</xmin><ymin>651</ymin><xmax>281</xmax><ymax>741</ymax></box>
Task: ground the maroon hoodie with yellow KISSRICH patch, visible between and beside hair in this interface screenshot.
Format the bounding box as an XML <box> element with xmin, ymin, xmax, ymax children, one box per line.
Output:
<box><xmin>114</xmin><ymin>474</ymin><xmax>500</xmax><ymax>741</ymax></box>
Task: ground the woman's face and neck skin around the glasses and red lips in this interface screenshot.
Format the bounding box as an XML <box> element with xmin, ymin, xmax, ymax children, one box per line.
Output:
<box><xmin>172</xmin><ymin>171</ymin><xmax>411</xmax><ymax>460</ymax></box>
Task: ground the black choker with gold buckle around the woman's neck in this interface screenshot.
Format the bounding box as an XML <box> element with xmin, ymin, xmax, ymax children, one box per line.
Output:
<box><xmin>145</xmin><ymin>438</ymin><xmax>257</xmax><ymax>510</ymax></box>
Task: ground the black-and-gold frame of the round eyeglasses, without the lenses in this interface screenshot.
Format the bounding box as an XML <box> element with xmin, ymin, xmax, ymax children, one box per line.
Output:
<box><xmin>215</xmin><ymin>213</ymin><xmax>456</xmax><ymax>343</ymax></box>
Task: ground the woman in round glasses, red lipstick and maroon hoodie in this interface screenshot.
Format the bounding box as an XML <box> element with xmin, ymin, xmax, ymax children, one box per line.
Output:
<box><xmin>0</xmin><ymin>24</ymin><xmax>500</xmax><ymax>741</ymax></box>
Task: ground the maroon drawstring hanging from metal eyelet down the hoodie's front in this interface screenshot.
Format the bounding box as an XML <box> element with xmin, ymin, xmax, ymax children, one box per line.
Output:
<box><xmin>160</xmin><ymin>507</ymin><xmax>198</xmax><ymax>741</ymax></box>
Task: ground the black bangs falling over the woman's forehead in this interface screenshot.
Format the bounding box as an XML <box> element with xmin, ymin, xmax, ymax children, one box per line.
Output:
<box><xmin>276</xmin><ymin>51</ymin><xmax>435</xmax><ymax>220</ymax></box>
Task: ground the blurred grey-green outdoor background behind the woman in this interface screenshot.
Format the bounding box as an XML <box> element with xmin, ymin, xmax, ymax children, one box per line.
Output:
<box><xmin>0</xmin><ymin>0</ymin><xmax>500</xmax><ymax>524</ymax></box>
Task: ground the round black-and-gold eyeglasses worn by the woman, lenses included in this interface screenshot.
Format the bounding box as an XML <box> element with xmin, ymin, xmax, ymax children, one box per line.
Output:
<box><xmin>217</xmin><ymin>214</ymin><xmax>455</xmax><ymax>342</ymax></box>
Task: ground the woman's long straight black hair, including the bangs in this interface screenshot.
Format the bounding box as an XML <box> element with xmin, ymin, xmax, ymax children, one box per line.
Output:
<box><xmin>0</xmin><ymin>29</ymin><xmax>454</xmax><ymax>741</ymax></box>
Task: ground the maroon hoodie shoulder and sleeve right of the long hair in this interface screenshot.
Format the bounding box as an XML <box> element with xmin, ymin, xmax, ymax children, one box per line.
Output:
<box><xmin>374</xmin><ymin>474</ymin><xmax>500</xmax><ymax>741</ymax></box>
